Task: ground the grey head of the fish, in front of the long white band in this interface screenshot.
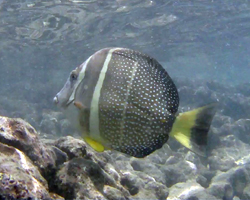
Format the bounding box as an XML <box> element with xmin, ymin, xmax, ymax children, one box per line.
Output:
<box><xmin>53</xmin><ymin>48</ymin><xmax>112</xmax><ymax>110</ymax></box>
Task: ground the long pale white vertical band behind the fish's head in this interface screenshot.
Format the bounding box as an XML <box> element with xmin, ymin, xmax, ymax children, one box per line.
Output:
<box><xmin>89</xmin><ymin>48</ymin><xmax>121</xmax><ymax>140</ymax></box>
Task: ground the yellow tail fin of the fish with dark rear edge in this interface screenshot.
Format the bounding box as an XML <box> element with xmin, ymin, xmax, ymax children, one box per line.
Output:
<box><xmin>170</xmin><ymin>103</ymin><xmax>217</xmax><ymax>156</ymax></box>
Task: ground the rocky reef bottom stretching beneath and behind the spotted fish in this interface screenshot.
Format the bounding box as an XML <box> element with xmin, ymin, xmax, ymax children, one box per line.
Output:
<box><xmin>0</xmin><ymin>80</ymin><xmax>250</xmax><ymax>200</ymax></box>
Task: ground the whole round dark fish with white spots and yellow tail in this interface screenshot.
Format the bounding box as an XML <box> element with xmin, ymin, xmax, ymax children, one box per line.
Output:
<box><xmin>54</xmin><ymin>48</ymin><xmax>215</xmax><ymax>158</ymax></box>
